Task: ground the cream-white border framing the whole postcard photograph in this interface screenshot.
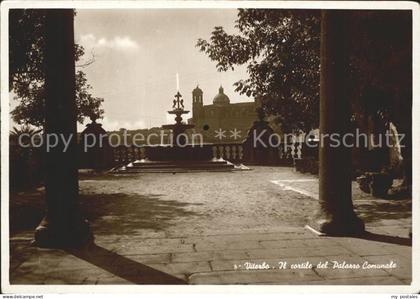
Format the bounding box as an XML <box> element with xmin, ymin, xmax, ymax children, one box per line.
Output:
<box><xmin>1</xmin><ymin>0</ymin><xmax>420</xmax><ymax>294</ymax></box>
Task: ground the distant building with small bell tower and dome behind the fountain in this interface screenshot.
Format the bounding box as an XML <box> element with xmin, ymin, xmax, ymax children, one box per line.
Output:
<box><xmin>188</xmin><ymin>86</ymin><xmax>257</xmax><ymax>137</ymax></box>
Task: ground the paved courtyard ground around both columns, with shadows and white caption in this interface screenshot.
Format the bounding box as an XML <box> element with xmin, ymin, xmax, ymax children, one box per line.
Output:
<box><xmin>10</xmin><ymin>167</ymin><xmax>412</xmax><ymax>285</ymax></box>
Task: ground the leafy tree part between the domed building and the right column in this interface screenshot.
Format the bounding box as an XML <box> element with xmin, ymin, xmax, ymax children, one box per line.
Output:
<box><xmin>197</xmin><ymin>9</ymin><xmax>320</xmax><ymax>132</ymax></box>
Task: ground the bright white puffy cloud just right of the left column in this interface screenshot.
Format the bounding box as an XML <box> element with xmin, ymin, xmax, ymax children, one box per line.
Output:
<box><xmin>78</xmin><ymin>33</ymin><xmax>140</xmax><ymax>52</ymax></box>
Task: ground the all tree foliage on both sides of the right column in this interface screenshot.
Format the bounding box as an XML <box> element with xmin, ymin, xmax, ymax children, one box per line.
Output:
<box><xmin>197</xmin><ymin>9</ymin><xmax>412</xmax><ymax>131</ymax></box>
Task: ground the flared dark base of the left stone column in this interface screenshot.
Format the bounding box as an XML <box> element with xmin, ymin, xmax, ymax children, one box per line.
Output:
<box><xmin>33</xmin><ymin>217</ymin><xmax>93</xmax><ymax>248</ymax></box>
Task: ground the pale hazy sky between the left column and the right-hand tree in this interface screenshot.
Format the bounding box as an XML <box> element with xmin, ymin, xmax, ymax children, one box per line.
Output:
<box><xmin>75</xmin><ymin>9</ymin><xmax>250</xmax><ymax>130</ymax></box>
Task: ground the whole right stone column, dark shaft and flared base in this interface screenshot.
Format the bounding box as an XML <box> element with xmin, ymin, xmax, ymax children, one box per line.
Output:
<box><xmin>311</xmin><ymin>10</ymin><xmax>364</xmax><ymax>235</ymax></box>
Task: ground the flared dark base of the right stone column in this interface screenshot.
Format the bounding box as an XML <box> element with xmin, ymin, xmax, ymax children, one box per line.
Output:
<box><xmin>307</xmin><ymin>214</ymin><xmax>365</xmax><ymax>236</ymax></box>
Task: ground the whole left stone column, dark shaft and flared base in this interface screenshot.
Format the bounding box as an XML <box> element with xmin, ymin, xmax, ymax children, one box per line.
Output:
<box><xmin>35</xmin><ymin>9</ymin><xmax>91</xmax><ymax>247</ymax></box>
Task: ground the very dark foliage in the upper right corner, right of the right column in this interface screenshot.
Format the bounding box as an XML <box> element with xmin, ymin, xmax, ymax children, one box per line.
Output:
<box><xmin>349</xmin><ymin>11</ymin><xmax>412</xmax><ymax>127</ymax></box>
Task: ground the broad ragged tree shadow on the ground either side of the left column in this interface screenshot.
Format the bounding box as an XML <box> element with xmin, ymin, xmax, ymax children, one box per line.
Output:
<box><xmin>9</xmin><ymin>191</ymin><xmax>200</xmax><ymax>235</ymax></box>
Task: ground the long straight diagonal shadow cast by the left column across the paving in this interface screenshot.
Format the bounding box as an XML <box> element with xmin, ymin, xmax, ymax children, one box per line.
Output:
<box><xmin>67</xmin><ymin>243</ymin><xmax>187</xmax><ymax>284</ymax></box>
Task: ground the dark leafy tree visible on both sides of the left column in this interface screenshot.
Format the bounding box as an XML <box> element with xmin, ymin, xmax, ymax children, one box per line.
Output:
<box><xmin>9</xmin><ymin>9</ymin><xmax>104</xmax><ymax>127</ymax></box>
